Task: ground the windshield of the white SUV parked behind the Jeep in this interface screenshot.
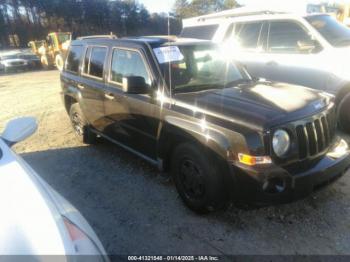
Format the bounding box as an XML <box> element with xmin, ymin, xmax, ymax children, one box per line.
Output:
<box><xmin>306</xmin><ymin>15</ymin><xmax>350</xmax><ymax>47</ymax></box>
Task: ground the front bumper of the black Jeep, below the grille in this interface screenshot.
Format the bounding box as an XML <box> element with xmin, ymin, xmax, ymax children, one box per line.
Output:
<box><xmin>231</xmin><ymin>140</ymin><xmax>350</xmax><ymax>205</ymax></box>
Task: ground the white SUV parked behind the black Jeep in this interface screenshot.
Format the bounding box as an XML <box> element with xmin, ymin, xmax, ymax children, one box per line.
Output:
<box><xmin>181</xmin><ymin>8</ymin><xmax>350</xmax><ymax>132</ymax></box>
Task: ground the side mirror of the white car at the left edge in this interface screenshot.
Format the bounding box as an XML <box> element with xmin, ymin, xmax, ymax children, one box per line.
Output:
<box><xmin>1</xmin><ymin>117</ymin><xmax>38</xmax><ymax>146</ymax></box>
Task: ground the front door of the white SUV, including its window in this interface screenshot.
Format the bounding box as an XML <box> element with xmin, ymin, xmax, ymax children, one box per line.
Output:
<box><xmin>261</xmin><ymin>20</ymin><xmax>328</xmax><ymax>89</ymax></box>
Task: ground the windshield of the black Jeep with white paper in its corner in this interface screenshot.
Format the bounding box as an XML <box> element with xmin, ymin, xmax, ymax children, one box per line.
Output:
<box><xmin>155</xmin><ymin>45</ymin><xmax>251</xmax><ymax>93</ymax></box>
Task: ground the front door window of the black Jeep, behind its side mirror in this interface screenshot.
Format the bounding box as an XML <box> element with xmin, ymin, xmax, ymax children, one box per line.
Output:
<box><xmin>110</xmin><ymin>49</ymin><xmax>151</xmax><ymax>85</ymax></box>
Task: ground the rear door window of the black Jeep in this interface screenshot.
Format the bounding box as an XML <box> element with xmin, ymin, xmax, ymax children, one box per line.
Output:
<box><xmin>84</xmin><ymin>47</ymin><xmax>107</xmax><ymax>78</ymax></box>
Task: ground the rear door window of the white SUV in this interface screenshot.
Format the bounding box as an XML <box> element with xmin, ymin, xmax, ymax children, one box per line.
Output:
<box><xmin>235</xmin><ymin>22</ymin><xmax>263</xmax><ymax>50</ymax></box>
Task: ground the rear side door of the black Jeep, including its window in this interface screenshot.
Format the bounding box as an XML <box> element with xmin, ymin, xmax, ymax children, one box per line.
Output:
<box><xmin>78</xmin><ymin>46</ymin><xmax>108</xmax><ymax>131</ymax></box>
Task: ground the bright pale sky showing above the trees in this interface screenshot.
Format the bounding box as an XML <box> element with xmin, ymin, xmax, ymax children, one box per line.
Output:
<box><xmin>139</xmin><ymin>0</ymin><xmax>350</xmax><ymax>13</ymax></box>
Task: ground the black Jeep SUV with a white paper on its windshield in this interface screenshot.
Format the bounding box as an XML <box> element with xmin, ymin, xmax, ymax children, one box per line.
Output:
<box><xmin>61</xmin><ymin>37</ymin><xmax>350</xmax><ymax>212</ymax></box>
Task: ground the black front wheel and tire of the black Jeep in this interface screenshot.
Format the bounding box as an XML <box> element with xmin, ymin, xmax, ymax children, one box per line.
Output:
<box><xmin>171</xmin><ymin>143</ymin><xmax>228</xmax><ymax>214</ymax></box>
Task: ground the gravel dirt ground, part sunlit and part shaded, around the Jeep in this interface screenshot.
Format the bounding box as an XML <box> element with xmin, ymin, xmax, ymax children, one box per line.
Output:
<box><xmin>0</xmin><ymin>71</ymin><xmax>350</xmax><ymax>255</ymax></box>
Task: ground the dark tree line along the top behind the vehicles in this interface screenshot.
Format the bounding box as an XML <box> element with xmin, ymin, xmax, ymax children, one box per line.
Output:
<box><xmin>0</xmin><ymin>0</ymin><xmax>236</xmax><ymax>47</ymax></box>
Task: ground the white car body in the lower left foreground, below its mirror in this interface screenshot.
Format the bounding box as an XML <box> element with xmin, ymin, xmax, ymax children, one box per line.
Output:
<box><xmin>0</xmin><ymin>138</ymin><xmax>105</xmax><ymax>255</ymax></box>
